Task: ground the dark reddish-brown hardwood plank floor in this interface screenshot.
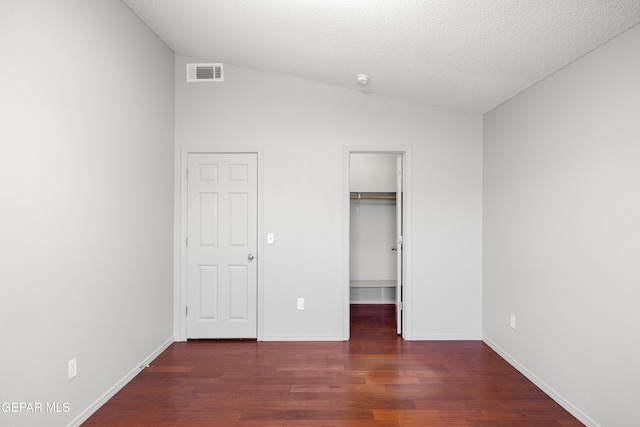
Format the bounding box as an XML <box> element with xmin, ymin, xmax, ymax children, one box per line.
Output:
<box><xmin>83</xmin><ymin>305</ymin><xmax>582</xmax><ymax>427</ymax></box>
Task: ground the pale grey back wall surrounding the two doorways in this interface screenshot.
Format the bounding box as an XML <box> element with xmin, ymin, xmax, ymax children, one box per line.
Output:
<box><xmin>176</xmin><ymin>55</ymin><xmax>482</xmax><ymax>340</ymax></box>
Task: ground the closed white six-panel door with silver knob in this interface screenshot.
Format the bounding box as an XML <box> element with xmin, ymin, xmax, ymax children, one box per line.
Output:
<box><xmin>187</xmin><ymin>153</ymin><xmax>258</xmax><ymax>338</ymax></box>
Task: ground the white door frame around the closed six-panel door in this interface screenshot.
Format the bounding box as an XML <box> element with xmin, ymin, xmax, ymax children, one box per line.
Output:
<box><xmin>173</xmin><ymin>147</ymin><xmax>264</xmax><ymax>341</ymax></box>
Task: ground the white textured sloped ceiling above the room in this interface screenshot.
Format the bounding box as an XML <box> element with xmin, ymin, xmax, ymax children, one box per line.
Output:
<box><xmin>123</xmin><ymin>0</ymin><xmax>640</xmax><ymax>113</ymax></box>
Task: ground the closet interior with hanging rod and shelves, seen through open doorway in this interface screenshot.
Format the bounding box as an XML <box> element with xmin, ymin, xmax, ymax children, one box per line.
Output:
<box><xmin>349</xmin><ymin>152</ymin><xmax>406</xmax><ymax>335</ymax></box>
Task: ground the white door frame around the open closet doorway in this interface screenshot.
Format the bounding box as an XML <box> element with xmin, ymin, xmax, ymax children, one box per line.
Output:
<box><xmin>342</xmin><ymin>147</ymin><xmax>413</xmax><ymax>341</ymax></box>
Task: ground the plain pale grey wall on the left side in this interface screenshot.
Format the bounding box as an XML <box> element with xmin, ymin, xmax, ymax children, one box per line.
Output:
<box><xmin>0</xmin><ymin>0</ymin><xmax>173</xmax><ymax>426</ymax></box>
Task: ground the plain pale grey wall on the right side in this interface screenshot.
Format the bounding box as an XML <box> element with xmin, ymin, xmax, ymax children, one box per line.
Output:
<box><xmin>483</xmin><ymin>22</ymin><xmax>640</xmax><ymax>426</ymax></box>
